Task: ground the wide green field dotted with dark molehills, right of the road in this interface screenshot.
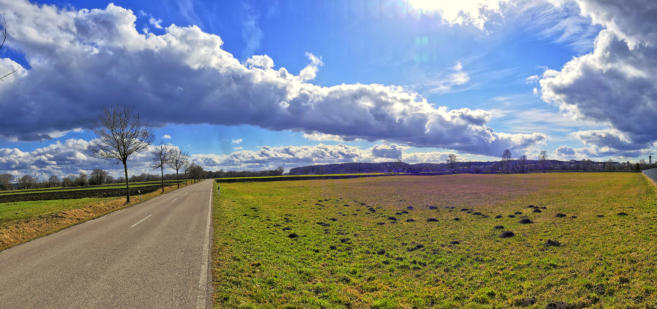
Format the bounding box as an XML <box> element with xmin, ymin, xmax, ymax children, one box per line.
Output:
<box><xmin>214</xmin><ymin>173</ymin><xmax>657</xmax><ymax>308</ymax></box>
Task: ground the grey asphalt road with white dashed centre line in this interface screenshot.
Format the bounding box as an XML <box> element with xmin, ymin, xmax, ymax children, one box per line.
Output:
<box><xmin>0</xmin><ymin>180</ymin><xmax>212</xmax><ymax>308</ymax></box>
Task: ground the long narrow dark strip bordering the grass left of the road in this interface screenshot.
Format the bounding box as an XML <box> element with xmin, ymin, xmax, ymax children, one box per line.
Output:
<box><xmin>0</xmin><ymin>185</ymin><xmax>161</xmax><ymax>203</ymax></box>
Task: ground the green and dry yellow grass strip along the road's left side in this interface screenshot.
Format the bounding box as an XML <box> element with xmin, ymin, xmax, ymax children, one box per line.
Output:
<box><xmin>0</xmin><ymin>184</ymin><xmax>190</xmax><ymax>251</ymax></box>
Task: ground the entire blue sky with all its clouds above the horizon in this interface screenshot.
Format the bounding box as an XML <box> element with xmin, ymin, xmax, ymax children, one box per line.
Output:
<box><xmin>0</xmin><ymin>0</ymin><xmax>657</xmax><ymax>178</ymax></box>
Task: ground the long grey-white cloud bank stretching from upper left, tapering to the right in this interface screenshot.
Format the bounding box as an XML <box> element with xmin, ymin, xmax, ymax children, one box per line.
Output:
<box><xmin>0</xmin><ymin>0</ymin><xmax>546</xmax><ymax>155</ymax></box>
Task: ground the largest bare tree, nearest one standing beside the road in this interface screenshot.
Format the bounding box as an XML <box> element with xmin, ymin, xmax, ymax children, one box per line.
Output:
<box><xmin>94</xmin><ymin>106</ymin><xmax>153</xmax><ymax>203</ymax></box>
